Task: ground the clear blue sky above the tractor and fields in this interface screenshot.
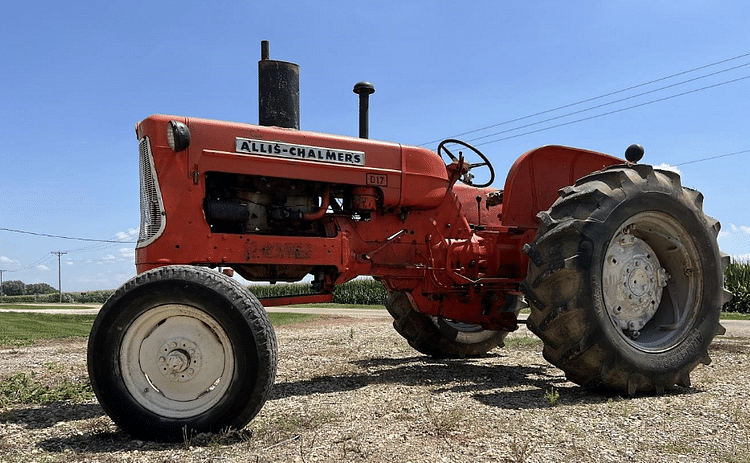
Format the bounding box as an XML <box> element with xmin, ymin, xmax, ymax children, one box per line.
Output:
<box><xmin>0</xmin><ymin>0</ymin><xmax>750</xmax><ymax>291</ymax></box>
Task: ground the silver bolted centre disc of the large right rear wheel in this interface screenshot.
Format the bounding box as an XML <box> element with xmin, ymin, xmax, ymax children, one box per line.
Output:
<box><xmin>602</xmin><ymin>229</ymin><xmax>669</xmax><ymax>339</ymax></box>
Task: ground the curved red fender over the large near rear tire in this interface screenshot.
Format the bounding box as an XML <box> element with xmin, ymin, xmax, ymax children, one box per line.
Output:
<box><xmin>502</xmin><ymin>145</ymin><xmax>625</xmax><ymax>228</ymax></box>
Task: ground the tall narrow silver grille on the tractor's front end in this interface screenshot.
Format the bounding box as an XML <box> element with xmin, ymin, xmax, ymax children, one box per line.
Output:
<box><xmin>137</xmin><ymin>137</ymin><xmax>166</xmax><ymax>247</ymax></box>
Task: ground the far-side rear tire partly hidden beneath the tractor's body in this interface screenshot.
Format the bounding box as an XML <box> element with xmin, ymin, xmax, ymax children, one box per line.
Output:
<box><xmin>385</xmin><ymin>291</ymin><xmax>521</xmax><ymax>358</ymax></box>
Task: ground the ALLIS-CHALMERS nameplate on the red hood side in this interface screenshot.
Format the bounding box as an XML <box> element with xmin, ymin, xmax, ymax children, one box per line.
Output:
<box><xmin>235</xmin><ymin>138</ymin><xmax>365</xmax><ymax>166</ymax></box>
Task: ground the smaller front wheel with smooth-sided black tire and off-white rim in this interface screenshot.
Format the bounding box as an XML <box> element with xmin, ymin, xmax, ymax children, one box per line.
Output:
<box><xmin>88</xmin><ymin>266</ymin><xmax>277</xmax><ymax>441</ymax></box>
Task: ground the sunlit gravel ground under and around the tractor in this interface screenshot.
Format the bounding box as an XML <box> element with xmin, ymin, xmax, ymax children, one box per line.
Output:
<box><xmin>0</xmin><ymin>317</ymin><xmax>750</xmax><ymax>463</ymax></box>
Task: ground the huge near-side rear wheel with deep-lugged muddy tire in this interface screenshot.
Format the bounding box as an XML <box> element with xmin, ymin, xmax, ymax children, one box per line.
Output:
<box><xmin>522</xmin><ymin>165</ymin><xmax>731</xmax><ymax>395</ymax></box>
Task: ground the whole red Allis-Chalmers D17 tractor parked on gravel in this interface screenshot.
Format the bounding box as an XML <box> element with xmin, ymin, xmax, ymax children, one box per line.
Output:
<box><xmin>88</xmin><ymin>42</ymin><xmax>731</xmax><ymax>440</ymax></box>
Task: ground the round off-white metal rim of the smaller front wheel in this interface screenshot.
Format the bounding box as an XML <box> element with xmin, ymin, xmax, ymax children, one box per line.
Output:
<box><xmin>120</xmin><ymin>304</ymin><xmax>235</xmax><ymax>418</ymax></box>
